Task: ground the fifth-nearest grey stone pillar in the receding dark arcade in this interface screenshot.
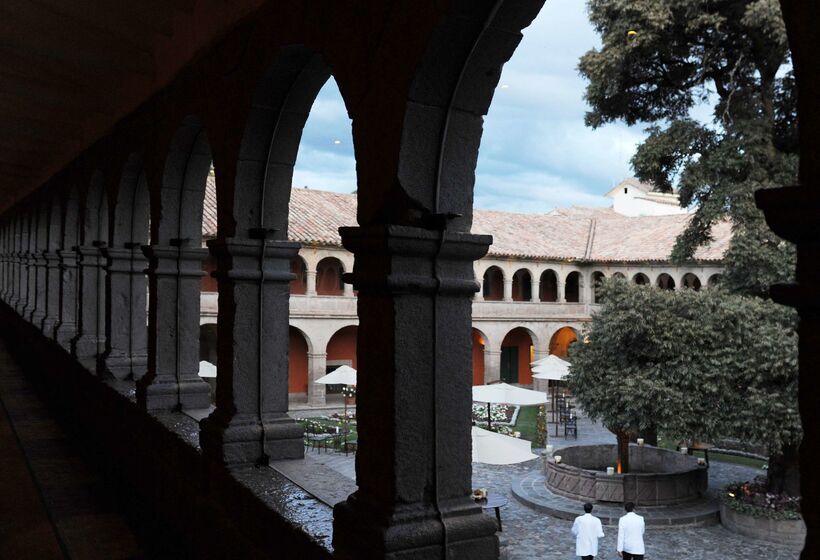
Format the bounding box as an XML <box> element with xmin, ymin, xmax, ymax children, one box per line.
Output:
<box><xmin>71</xmin><ymin>245</ymin><xmax>105</xmax><ymax>372</ymax></box>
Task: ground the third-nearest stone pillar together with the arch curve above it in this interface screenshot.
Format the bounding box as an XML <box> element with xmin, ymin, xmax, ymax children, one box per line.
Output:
<box><xmin>143</xmin><ymin>115</ymin><xmax>216</xmax><ymax>410</ymax></box>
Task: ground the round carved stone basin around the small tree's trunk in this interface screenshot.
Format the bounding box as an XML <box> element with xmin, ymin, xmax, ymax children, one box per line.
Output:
<box><xmin>544</xmin><ymin>444</ymin><xmax>709</xmax><ymax>506</ymax></box>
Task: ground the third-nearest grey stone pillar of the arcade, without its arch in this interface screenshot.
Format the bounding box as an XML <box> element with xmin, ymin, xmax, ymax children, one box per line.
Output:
<box><xmin>137</xmin><ymin>245</ymin><xmax>210</xmax><ymax>410</ymax></box>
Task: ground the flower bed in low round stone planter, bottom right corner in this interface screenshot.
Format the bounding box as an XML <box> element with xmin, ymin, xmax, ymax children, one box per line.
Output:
<box><xmin>720</xmin><ymin>477</ymin><xmax>806</xmax><ymax>546</ymax></box>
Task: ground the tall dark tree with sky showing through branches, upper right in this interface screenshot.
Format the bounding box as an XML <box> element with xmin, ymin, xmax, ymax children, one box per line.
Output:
<box><xmin>579</xmin><ymin>0</ymin><xmax>798</xmax><ymax>295</ymax></box>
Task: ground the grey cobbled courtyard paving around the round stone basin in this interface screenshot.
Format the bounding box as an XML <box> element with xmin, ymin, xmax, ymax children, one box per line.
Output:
<box><xmin>297</xmin><ymin>418</ymin><xmax>799</xmax><ymax>560</ymax></box>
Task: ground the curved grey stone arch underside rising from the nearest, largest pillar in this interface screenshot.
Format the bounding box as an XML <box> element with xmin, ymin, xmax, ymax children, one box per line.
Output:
<box><xmin>396</xmin><ymin>0</ymin><xmax>543</xmax><ymax>231</ymax></box>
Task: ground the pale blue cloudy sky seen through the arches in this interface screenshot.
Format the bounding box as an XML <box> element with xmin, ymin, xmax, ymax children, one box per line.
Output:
<box><xmin>293</xmin><ymin>0</ymin><xmax>644</xmax><ymax>212</ymax></box>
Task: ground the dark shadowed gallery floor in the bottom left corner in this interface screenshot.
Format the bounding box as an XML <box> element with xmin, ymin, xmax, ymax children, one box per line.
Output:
<box><xmin>0</xmin><ymin>340</ymin><xmax>187</xmax><ymax>560</ymax></box>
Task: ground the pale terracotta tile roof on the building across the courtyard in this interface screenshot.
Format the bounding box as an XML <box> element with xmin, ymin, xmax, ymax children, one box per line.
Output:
<box><xmin>203</xmin><ymin>184</ymin><xmax>731</xmax><ymax>262</ymax></box>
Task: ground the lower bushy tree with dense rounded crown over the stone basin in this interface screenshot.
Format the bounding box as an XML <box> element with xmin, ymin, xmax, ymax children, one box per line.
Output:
<box><xmin>568</xmin><ymin>278</ymin><xmax>801</xmax><ymax>495</ymax></box>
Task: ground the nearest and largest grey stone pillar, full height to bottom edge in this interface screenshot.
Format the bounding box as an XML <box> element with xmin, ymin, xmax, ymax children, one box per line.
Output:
<box><xmin>333</xmin><ymin>225</ymin><xmax>499</xmax><ymax>560</ymax></box>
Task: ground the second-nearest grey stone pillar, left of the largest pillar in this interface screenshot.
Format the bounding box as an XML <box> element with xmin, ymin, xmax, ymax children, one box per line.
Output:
<box><xmin>200</xmin><ymin>238</ymin><xmax>310</xmax><ymax>465</ymax></box>
